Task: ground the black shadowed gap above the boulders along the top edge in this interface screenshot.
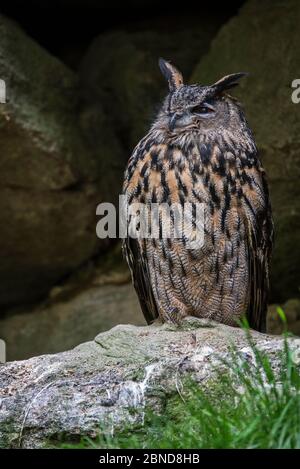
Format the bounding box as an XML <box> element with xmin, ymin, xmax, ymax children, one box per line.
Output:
<box><xmin>0</xmin><ymin>0</ymin><xmax>244</xmax><ymax>64</ymax></box>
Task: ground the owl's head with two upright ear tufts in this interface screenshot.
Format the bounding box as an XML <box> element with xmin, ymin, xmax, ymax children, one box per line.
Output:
<box><xmin>157</xmin><ymin>59</ymin><xmax>246</xmax><ymax>134</ymax></box>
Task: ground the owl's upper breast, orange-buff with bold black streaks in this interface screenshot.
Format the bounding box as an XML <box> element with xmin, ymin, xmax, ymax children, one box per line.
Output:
<box><xmin>124</xmin><ymin>140</ymin><xmax>265</xmax><ymax>245</ymax></box>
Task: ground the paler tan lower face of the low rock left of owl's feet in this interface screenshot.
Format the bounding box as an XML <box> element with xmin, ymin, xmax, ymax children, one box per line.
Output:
<box><xmin>0</xmin><ymin>283</ymin><xmax>145</xmax><ymax>360</ymax></box>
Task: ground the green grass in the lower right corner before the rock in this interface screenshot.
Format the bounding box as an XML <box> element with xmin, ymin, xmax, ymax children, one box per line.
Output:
<box><xmin>59</xmin><ymin>316</ymin><xmax>300</xmax><ymax>449</ymax></box>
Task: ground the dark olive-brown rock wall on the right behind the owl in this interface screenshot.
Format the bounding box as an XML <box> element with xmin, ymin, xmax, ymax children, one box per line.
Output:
<box><xmin>191</xmin><ymin>0</ymin><xmax>300</xmax><ymax>301</ymax></box>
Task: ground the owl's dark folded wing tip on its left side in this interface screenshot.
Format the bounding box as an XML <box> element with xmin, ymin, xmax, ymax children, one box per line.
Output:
<box><xmin>123</xmin><ymin>237</ymin><xmax>158</xmax><ymax>324</ymax></box>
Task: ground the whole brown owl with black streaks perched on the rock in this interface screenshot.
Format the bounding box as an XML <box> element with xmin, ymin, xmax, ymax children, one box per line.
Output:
<box><xmin>123</xmin><ymin>59</ymin><xmax>273</xmax><ymax>331</ymax></box>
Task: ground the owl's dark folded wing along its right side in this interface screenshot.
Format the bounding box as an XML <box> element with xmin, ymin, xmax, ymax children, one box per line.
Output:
<box><xmin>247</xmin><ymin>177</ymin><xmax>274</xmax><ymax>332</ymax></box>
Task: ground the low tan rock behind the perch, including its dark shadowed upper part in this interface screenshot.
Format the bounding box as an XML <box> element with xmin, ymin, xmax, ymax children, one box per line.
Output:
<box><xmin>0</xmin><ymin>244</ymin><xmax>145</xmax><ymax>361</ymax></box>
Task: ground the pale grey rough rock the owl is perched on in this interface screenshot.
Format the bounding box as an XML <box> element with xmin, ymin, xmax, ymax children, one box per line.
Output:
<box><xmin>0</xmin><ymin>318</ymin><xmax>300</xmax><ymax>448</ymax></box>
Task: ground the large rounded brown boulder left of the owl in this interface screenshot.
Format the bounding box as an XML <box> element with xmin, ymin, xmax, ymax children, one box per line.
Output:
<box><xmin>0</xmin><ymin>16</ymin><xmax>121</xmax><ymax>308</ymax></box>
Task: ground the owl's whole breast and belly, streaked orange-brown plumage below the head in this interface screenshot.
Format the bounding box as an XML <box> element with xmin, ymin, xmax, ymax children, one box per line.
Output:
<box><xmin>123</xmin><ymin>129</ymin><xmax>269</xmax><ymax>324</ymax></box>
